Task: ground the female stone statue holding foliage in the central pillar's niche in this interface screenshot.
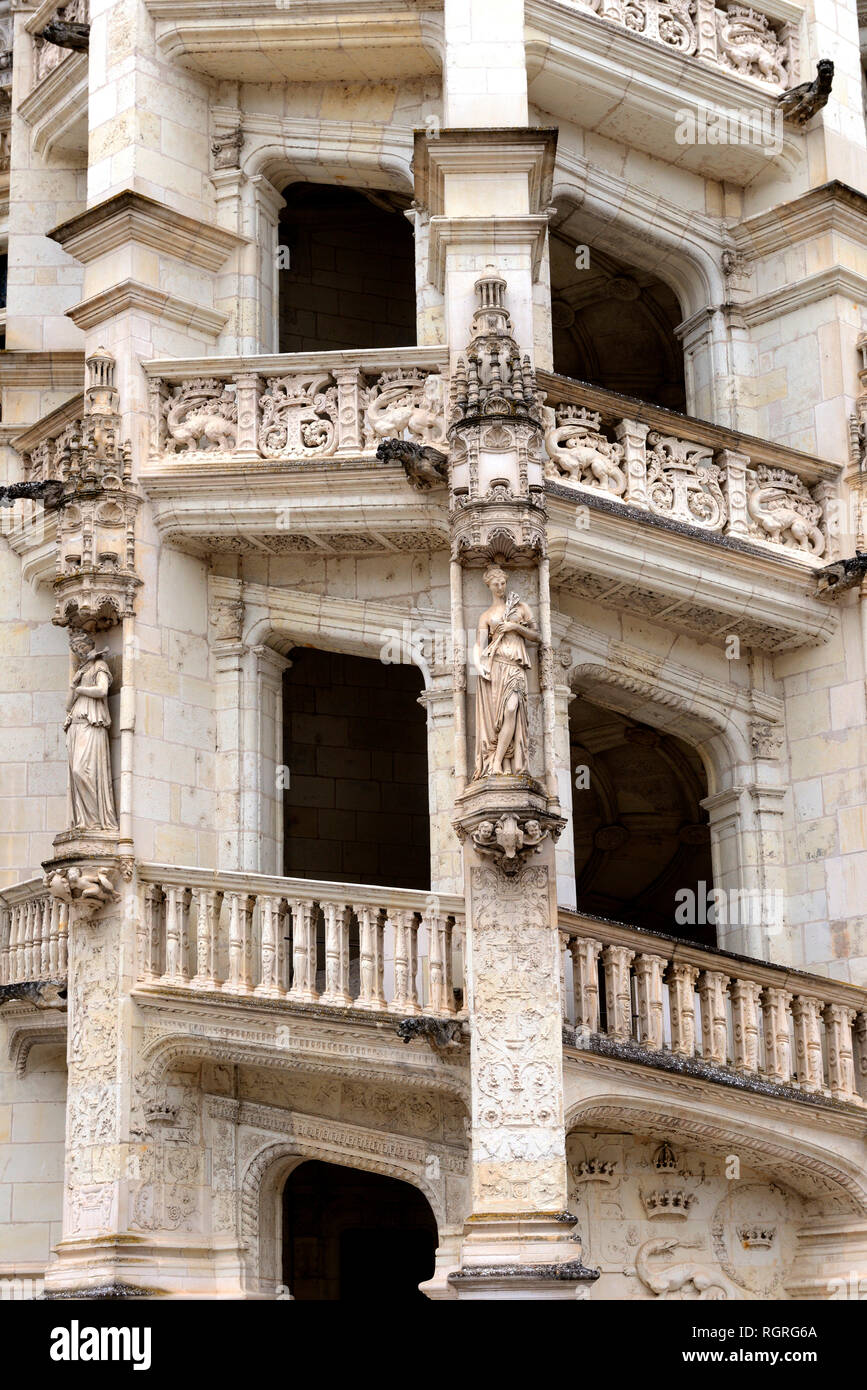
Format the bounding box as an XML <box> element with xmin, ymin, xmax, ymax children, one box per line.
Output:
<box><xmin>474</xmin><ymin>564</ymin><xmax>540</xmax><ymax>777</ymax></box>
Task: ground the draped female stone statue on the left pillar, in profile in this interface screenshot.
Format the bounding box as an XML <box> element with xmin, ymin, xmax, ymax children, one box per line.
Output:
<box><xmin>64</xmin><ymin>631</ymin><xmax>118</xmax><ymax>830</ymax></box>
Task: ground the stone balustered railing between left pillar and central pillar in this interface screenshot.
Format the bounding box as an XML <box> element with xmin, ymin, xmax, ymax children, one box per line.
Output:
<box><xmin>138</xmin><ymin>865</ymin><xmax>464</xmax><ymax>1017</ymax></box>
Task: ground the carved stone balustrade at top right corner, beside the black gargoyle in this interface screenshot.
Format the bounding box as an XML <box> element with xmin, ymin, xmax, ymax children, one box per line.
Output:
<box><xmin>575</xmin><ymin>0</ymin><xmax>798</xmax><ymax>88</ymax></box>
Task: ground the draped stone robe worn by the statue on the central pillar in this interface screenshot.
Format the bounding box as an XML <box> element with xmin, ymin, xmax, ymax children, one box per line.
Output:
<box><xmin>474</xmin><ymin>594</ymin><xmax>529</xmax><ymax>777</ymax></box>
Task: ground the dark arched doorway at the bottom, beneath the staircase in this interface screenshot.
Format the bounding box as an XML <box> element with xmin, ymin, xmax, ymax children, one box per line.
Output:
<box><xmin>283</xmin><ymin>1159</ymin><xmax>438</xmax><ymax>1305</ymax></box>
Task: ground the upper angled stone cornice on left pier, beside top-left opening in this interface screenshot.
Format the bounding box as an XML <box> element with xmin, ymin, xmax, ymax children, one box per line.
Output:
<box><xmin>46</xmin><ymin>190</ymin><xmax>249</xmax><ymax>271</ymax></box>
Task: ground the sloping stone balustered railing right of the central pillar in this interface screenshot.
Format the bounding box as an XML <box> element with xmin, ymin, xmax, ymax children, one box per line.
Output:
<box><xmin>560</xmin><ymin>910</ymin><xmax>867</xmax><ymax>1105</ymax></box>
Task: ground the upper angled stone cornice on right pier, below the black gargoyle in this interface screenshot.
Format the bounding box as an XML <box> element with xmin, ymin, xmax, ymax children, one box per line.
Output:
<box><xmin>729</xmin><ymin>179</ymin><xmax>867</xmax><ymax>260</ymax></box>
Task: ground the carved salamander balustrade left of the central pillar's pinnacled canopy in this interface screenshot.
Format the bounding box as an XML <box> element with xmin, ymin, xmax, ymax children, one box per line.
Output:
<box><xmin>145</xmin><ymin>348</ymin><xmax>447</xmax><ymax>464</ymax></box>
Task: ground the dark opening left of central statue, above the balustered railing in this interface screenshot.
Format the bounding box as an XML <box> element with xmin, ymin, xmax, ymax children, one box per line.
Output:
<box><xmin>283</xmin><ymin>648</ymin><xmax>431</xmax><ymax>888</ymax></box>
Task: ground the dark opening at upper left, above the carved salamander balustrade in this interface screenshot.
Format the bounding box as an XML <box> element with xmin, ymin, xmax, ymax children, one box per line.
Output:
<box><xmin>278</xmin><ymin>183</ymin><xmax>415</xmax><ymax>352</ymax></box>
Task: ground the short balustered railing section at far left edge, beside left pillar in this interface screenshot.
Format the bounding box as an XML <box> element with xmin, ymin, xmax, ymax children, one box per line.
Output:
<box><xmin>0</xmin><ymin>878</ymin><xmax>68</xmax><ymax>986</ymax></box>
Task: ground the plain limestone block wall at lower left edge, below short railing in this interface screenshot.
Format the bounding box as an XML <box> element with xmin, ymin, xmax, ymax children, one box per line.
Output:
<box><xmin>0</xmin><ymin>1034</ymin><xmax>67</xmax><ymax>1278</ymax></box>
